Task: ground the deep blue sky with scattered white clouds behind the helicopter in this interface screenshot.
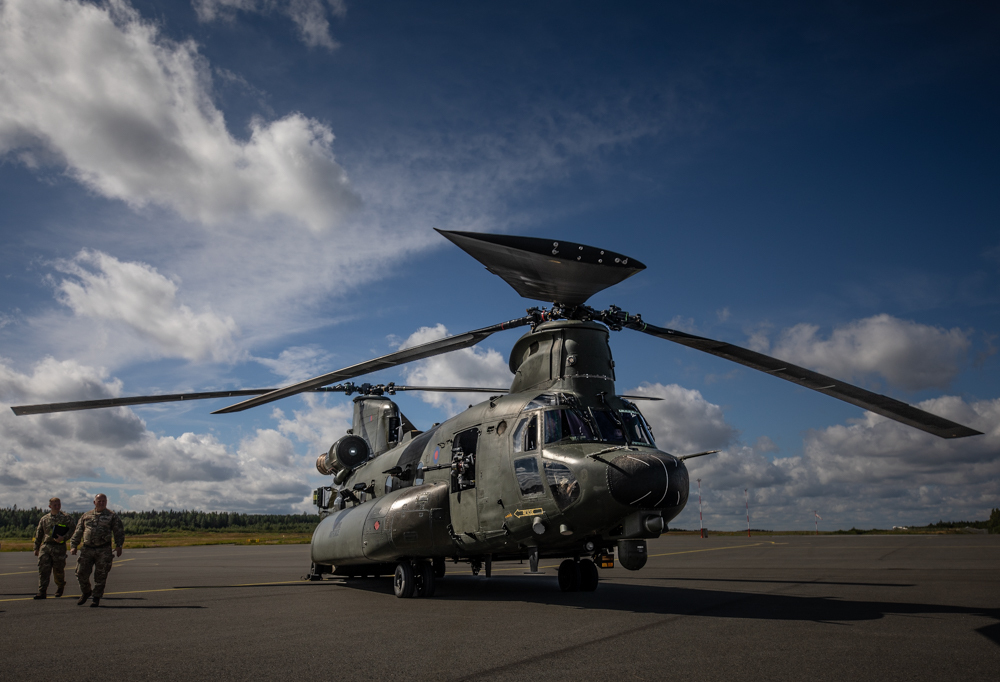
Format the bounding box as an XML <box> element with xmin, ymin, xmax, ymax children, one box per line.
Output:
<box><xmin>0</xmin><ymin>0</ymin><xmax>1000</xmax><ymax>529</ymax></box>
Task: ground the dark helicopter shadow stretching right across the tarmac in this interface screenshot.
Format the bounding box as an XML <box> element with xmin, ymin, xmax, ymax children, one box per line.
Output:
<box><xmin>334</xmin><ymin>576</ymin><xmax>1000</xmax><ymax>646</ymax></box>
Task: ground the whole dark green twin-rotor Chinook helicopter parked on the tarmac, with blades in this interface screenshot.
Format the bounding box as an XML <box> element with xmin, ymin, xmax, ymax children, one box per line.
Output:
<box><xmin>13</xmin><ymin>230</ymin><xmax>980</xmax><ymax>597</ymax></box>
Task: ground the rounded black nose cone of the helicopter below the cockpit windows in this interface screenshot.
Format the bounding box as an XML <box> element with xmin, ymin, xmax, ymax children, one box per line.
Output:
<box><xmin>607</xmin><ymin>452</ymin><xmax>688</xmax><ymax>509</ymax></box>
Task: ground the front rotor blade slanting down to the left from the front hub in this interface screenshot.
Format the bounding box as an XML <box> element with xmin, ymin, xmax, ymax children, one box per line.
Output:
<box><xmin>212</xmin><ymin>315</ymin><xmax>535</xmax><ymax>414</ymax></box>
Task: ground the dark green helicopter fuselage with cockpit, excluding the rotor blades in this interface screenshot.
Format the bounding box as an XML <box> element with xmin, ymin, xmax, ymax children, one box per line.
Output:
<box><xmin>312</xmin><ymin>320</ymin><xmax>688</xmax><ymax>574</ymax></box>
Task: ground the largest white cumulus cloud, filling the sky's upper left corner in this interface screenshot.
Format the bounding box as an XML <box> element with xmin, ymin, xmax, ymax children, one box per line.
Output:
<box><xmin>0</xmin><ymin>0</ymin><xmax>360</xmax><ymax>231</ymax></box>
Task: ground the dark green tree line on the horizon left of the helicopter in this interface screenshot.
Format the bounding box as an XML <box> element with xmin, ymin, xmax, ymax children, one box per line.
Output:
<box><xmin>0</xmin><ymin>505</ymin><xmax>319</xmax><ymax>538</ymax></box>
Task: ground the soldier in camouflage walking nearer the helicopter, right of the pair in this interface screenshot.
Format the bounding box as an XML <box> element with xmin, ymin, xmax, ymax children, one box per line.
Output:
<box><xmin>69</xmin><ymin>494</ymin><xmax>125</xmax><ymax>606</ymax></box>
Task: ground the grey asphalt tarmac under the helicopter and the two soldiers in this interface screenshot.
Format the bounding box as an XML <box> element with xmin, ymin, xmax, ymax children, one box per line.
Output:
<box><xmin>0</xmin><ymin>535</ymin><xmax>1000</xmax><ymax>682</ymax></box>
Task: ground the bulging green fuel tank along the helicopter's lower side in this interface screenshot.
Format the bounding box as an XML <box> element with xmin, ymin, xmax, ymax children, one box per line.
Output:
<box><xmin>312</xmin><ymin>481</ymin><xmax>453</xmax><ymax>566</ymax></box>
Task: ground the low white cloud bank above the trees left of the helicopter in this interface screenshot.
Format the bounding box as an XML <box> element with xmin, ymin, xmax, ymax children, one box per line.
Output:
<box><xmin>0</xmin><ymin>358</ymin><xmax>326</xmax><ymax>512</ymax></box>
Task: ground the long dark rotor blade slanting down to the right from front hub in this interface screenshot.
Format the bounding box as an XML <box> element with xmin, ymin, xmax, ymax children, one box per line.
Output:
<box><xmin>625</xmin><ymin>321</ymin><xmax>982</xmax><ymax>438</ymax></box>
